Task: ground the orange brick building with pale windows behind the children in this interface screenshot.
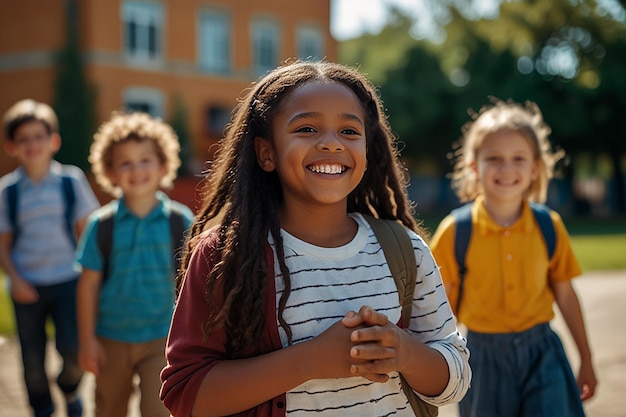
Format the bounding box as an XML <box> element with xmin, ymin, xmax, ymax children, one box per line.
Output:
<box><xmin>0</xmin><ymin>0</ymin><xmax>337</xmax><ymax>180</ymax></box>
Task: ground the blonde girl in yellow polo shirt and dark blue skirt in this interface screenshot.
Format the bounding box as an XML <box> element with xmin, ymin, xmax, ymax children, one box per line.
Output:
<box><xmin>430</xmin><ymin>100</ymin><xmax>597</xmax><ymax>417</ymax></box>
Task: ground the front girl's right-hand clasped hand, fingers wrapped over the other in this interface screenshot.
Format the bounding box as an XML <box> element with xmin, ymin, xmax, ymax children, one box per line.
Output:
<box><xmin>342</xmin><ymin>306</ymin><xmax>410</xmax><ymax>382</ymax></box>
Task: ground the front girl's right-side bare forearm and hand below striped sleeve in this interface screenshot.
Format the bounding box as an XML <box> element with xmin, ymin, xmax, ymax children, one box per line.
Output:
<box><xmin>343</xmin><ymin>306</ymin><xmax>450</xmax><ymax>397</ymax></box>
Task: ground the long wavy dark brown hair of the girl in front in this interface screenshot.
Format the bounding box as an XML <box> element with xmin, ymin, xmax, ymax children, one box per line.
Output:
<box><xmin>178</xmin><ymin>61</ymin><xmax>424</xmax><ymax>357</ymax></box>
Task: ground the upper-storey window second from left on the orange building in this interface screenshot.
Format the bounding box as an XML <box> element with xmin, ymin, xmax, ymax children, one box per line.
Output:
<box><xmin>198</xmin><ymin>11</ymin><xmax>231</xmax><ymax>74</ymax></box>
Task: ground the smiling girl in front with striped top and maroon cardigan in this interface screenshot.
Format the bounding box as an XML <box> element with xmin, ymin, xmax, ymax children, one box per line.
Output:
<box><xmin>161</xmin><ymin>62</ymin><xmax>470</xmax><ymax>417</ymax></box>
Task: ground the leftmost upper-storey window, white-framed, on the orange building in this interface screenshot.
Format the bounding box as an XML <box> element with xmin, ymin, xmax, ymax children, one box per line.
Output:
<box><xmin>122</xmin><ymin>1</ymin><xmax>163</xmax><ymax>63</ymax></box>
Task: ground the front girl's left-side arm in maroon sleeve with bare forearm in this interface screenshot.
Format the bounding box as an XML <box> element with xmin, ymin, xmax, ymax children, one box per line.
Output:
<box><xmin>161</xmin><ymin>237</ymin><xmax>360</xmax><ymax>417</ymax></box>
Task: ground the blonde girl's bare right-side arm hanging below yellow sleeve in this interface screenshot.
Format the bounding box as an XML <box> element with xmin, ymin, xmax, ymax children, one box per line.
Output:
<box><xmin>552</xmin><ymin>281</ymin><xmax>598</xmax><ymax>401</ymax></box>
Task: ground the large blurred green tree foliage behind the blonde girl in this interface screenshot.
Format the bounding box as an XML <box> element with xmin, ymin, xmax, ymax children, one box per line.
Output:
<box><xmin>340</xmin><ymin>0</ymin><xmax>626</xmax><ymax>213</ymax></box>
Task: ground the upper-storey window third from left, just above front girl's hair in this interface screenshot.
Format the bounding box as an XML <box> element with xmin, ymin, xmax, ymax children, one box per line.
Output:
<box><xmin>252</xmin><ymin>20</ymin><xmax>280</xmax><ymax>76</ymax></box>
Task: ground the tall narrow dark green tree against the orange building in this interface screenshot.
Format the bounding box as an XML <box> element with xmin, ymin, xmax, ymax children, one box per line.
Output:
<box><xmin>53</xmin><ymin>0</ymin><xmax>96</xmax><ymax>170</ymax></box>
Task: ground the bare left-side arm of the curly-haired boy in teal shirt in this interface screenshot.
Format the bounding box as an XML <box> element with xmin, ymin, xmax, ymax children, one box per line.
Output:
<box><xmin>76</xmin><ymin>268</ymin><xmax>105</xmax><ymax>376</ymax></box>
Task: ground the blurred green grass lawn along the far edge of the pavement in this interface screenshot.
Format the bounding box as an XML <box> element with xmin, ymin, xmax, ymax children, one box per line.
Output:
<box><xmin>0</xmin><ymin>214</ymin><xmax>626</xmax><ymax>335</ymax></box>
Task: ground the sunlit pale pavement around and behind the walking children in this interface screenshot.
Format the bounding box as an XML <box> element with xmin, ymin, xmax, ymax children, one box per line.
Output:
<box><xmin>0</xmin><ymin>271</ymin><xmax>626</xmax><ymax>417</ymax></box>
